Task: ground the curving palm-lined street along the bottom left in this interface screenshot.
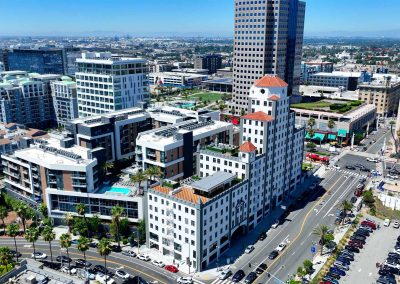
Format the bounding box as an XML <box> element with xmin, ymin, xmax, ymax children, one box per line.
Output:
<box><xmin>0</xmin><ymin>238</ymin><xmax>182</xmax><ymax>284</ymax></box>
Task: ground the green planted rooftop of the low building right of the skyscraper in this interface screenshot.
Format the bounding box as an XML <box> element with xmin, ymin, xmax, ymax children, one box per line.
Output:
<box><xmin>291</xmin><ymin>100</ymin><xmax>363</xmax><ymax>113</ymax></box>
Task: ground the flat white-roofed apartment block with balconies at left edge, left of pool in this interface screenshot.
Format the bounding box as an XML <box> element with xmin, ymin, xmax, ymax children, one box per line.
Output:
<box><xmin>1</xmin><ymin>135</ymin><xmax>104</xmax><ymax>202</ymax></box>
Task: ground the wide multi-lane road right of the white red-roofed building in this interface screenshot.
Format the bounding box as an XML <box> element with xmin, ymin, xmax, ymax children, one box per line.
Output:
<box><xmin>211</xmin><ymin>171</ymin><xmax>366</xmax><ymax>284</ymax></box>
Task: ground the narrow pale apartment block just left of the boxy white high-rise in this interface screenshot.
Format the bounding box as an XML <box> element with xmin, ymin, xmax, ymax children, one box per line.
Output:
<box><xmin>51</xmin><ymin>78</ymin><xmax>78</xmax><ymax>126</ymax></box>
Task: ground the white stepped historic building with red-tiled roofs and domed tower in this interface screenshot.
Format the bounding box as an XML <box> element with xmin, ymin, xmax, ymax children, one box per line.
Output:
<box><xmin>147</xmin><ymin>77</ymin><xmax>304</xmax><ymax>271</ymax></box>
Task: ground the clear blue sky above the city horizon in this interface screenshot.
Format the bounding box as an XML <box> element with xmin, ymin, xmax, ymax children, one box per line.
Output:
<box><xmin>0</xmin><ymin>0</ymin><xmax>400</xmax><ymax>37</ymax></box>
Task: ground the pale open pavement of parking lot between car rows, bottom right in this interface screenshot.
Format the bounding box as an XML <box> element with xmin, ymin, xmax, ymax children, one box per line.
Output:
<box><xmin>340</xmin><ymin>217</ymin><xmax>400</xmax><ymax>284</ymax></box>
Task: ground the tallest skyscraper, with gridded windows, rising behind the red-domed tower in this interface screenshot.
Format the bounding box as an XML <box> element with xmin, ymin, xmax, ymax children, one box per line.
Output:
<box><xmin>230</xmin><ymin>0</ymin><xmax>305</xmax><ymax>114</ymax></box>
